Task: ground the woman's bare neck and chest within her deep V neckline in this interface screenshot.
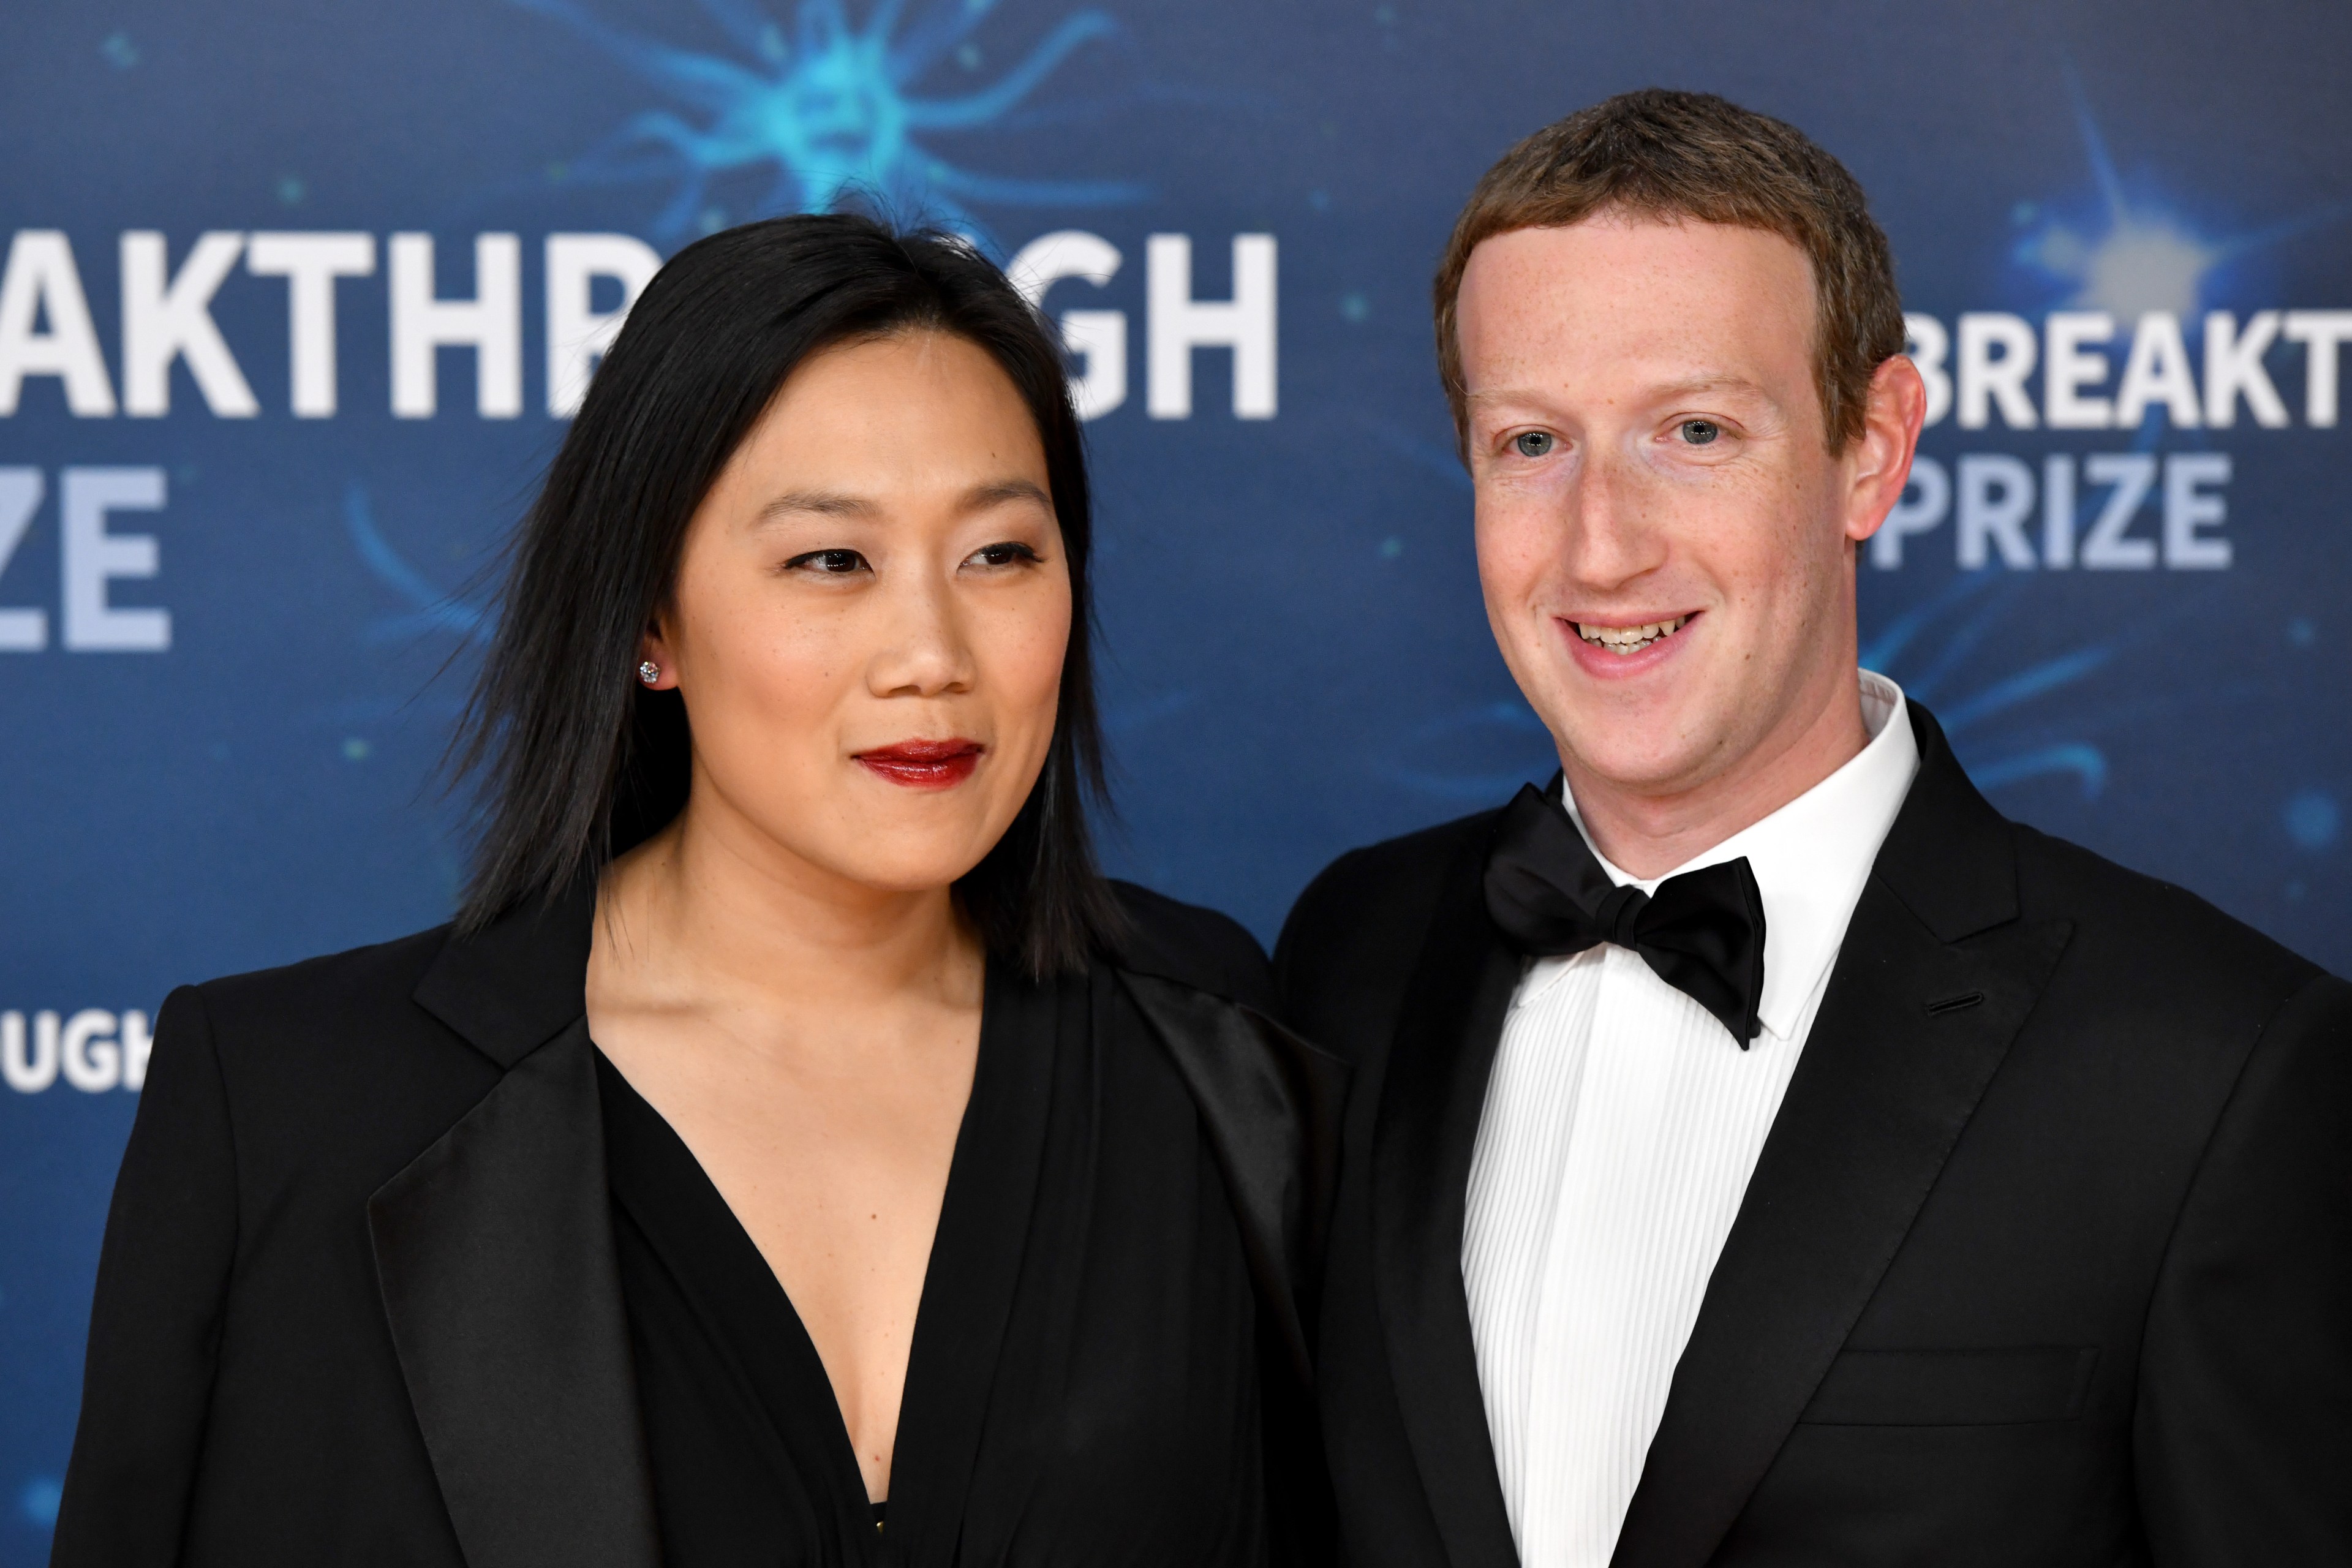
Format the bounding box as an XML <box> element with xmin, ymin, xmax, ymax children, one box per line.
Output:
<box><xmin>588</xmin><ymin>804</ymin><xmax>986</xmax><ymax>1498</ymax></box>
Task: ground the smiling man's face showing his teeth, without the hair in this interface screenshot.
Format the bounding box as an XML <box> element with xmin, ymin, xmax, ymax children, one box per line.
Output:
<box><xmin>1458</xmin><ymin>214</ymin><xmax>1917</xmax><ymax>797</ymax></box>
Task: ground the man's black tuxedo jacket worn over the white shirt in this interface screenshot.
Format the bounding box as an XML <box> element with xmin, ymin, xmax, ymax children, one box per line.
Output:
<box><xmin>1275</xmin><ymin>705</ymin><xmax>2352</xmax><ymax>1568</ymax></box>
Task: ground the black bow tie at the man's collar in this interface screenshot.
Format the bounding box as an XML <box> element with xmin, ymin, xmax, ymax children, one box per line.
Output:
<box><xmin>1487</xmin><ymin>778</ymin><xmax>1764</xmax><ymax>1051</ymax></box>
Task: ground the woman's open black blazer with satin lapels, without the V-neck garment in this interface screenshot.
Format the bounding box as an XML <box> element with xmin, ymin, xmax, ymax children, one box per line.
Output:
<box><xmin>51</xmin><ymin>886</ymin><xmax>1345</xmax><ymax>1568</ymax></box>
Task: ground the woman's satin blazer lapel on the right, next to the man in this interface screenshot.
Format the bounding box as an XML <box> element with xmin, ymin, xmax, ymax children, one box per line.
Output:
<box><xmin>1120</xmin><ymin>971</ymin><xmax>1348</xmax><ymax>1385</ymax></box>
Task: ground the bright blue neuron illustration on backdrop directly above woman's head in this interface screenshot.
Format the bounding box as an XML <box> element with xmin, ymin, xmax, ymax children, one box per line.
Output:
<box><xmin>513</xmin><ymin>0</ymin><xmax>1140</xmax><ymax>242</ymax></box>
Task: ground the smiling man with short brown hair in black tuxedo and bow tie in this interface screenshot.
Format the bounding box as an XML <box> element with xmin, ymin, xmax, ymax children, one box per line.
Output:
<box><xmin>1277</xmin><ymin>92</ymin><xmax>2352</xmax><ymax>1568</ymax></box>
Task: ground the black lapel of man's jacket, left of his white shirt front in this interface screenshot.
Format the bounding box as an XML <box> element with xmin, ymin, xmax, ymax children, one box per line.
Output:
<box><xmin>1371</xmin><ymin>837</ymin><xmax>1521</xmax><ymax>1568</ymax></box>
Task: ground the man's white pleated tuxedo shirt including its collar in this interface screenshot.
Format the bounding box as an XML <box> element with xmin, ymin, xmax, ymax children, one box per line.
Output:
<box><xmin>1463</xmin><ymin>670</ymin><xmax>1919</xmax><ymax>1568</ymax></box>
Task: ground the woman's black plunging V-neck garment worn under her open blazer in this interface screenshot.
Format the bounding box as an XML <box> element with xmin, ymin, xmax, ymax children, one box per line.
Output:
<box><xmin>597</xmin><ymin>971</ymin><xmax>1268</xmax><ymax>1568</ymax></box>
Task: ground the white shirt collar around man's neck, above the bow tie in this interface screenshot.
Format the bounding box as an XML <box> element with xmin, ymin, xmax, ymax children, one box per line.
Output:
<box><xmin>1564</xmin><ymin>670</ymin><xmax>1919</xmax><ymax>1039</ymax></box>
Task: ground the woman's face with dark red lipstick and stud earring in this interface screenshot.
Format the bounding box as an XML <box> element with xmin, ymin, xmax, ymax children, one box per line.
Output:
<box><xmin>644</xmin><ymin>331</ymin><xmax>1070</xmax><ymax>891</ymax></box>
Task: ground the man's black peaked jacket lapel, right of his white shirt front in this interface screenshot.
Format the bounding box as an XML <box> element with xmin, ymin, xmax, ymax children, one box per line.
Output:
<box><xmin>1611</xmin><ymin>893</ymin><xmax>2072</xmax><ymax>1568</ymax></box>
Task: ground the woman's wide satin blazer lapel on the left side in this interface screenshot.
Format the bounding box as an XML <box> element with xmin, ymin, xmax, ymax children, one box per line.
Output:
<box><xmin>367</xmin><ymin>1020</ymin><xmax>661</xmax><ymax>1568</ymax></box>
